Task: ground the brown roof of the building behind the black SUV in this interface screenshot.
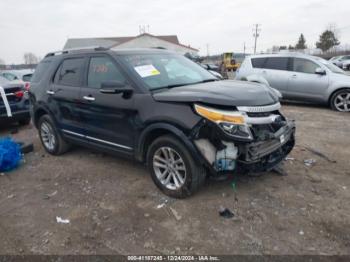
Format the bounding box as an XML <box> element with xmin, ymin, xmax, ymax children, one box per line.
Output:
<box><xmin>63</xmin><ymin>33</ymin><xmax>198</xmax><ymax>51</ymax></box>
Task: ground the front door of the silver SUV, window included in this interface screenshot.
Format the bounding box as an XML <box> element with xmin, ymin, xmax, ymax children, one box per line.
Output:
<box><xmin>288</xmin><ymin>58</ymin><xmax>329</xmax><ymax>101</ymax></box>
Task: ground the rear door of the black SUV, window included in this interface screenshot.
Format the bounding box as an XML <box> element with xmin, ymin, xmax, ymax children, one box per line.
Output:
<box><xmin>46</xmin><ymin>57</ymin><xmax>86</xmax><ymax>138</ymax></box>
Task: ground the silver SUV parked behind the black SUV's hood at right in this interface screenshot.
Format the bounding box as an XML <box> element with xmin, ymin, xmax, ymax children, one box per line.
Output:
<box><xmin>236</xmin><ymin>53</ymin><xmax>350</xmax><ymax>112</ymax></box>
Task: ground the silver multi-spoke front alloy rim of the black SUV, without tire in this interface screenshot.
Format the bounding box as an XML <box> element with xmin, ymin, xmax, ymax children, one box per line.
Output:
<box><xmin>153</xmin><ymin>147</ymin><xmax>186</xmax><ymax>190</ymax></box>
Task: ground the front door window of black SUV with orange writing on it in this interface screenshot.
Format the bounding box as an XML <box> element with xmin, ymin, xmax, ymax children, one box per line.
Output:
<box><xmin>88</xmin><ymin>57</ymin><xmax>125</xmax><ymax>88</ymax></box>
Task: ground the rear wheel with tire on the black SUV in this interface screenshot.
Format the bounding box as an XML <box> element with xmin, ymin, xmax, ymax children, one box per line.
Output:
<box><xmin>38</xmin><ymin>115</ymin><xmax>70</xmax><ymax>155</ymax></box>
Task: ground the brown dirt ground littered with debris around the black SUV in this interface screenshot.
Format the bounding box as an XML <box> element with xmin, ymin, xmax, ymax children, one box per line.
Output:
<box><xmin>0</xmin><ymin>104</ymin><xmax>350</xmax><ymax>254</ymax></box>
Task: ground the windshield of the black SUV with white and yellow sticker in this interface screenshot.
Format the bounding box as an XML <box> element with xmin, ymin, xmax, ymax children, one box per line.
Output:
<box><xmin>122</xmin><ymin>54</ymin><xmax>217</xmax><ymax>90</ymax></box>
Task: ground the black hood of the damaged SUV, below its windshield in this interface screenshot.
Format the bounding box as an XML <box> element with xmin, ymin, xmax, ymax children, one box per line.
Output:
<box><xmin>153</xmin><ymin>80</ymin><xmax>279</xmax><ymax>106</ymax></box>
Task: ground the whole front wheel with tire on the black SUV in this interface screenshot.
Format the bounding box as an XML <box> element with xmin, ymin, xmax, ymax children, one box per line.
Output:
<box><xmin>147</xmin><ymin>135</ymin><xmax>206</xmax><ymax>198</ymax></box>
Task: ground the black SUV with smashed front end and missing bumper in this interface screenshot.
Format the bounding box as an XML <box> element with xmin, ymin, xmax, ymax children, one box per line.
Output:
<box><xmin>30</xmin><ymin>48</ymin><xmax>295</xmax><ymax>198</ymax></box>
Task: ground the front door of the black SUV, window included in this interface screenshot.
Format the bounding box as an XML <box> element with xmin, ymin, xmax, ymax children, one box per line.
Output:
<box><xmin>79</xmin><ymin>55</ymin><xmax>136</xmax><ymax>153</ymax></box>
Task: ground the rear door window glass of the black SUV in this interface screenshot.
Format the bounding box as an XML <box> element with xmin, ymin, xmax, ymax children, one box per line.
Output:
<box><xmin>55</xmin><ymin>58</ymin><xmax>84</xmax><ymax>86</ymax></box>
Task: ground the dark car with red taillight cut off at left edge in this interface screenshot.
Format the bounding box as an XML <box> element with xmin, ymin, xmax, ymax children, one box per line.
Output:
<box><xmin>0</xmin><ymin>76</ymin><xmax>30</xmax><ymax>125</ymax></box>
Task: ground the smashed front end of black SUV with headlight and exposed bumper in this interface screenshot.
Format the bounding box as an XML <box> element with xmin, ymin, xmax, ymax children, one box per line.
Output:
<box><xmin>191</xmin><ymin>103</ymin><xmax>295</xmax><ymax>175</ymax></box>
